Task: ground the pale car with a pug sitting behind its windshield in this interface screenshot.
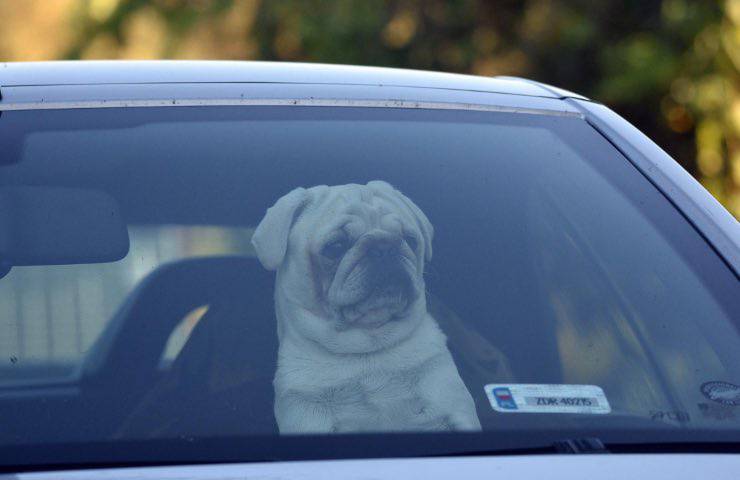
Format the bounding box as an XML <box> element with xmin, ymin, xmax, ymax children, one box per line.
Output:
<box><xmin>0</xmin><ymin>62</ymin><xmax>740</xmax><ymax>480</ymax></box>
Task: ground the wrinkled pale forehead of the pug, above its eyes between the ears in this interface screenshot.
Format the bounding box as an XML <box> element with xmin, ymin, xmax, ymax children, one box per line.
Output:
<box><xmin>302</xmin><ymin>185</ymin><xmax>414</xmax><ymax>237</ymax></box>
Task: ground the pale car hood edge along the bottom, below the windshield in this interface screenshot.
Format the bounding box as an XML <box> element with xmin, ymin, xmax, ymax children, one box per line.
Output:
<box><xmin>5</xmin><ymin>454</ymin><xmax>740</xmax><ymax>480</ymax></box>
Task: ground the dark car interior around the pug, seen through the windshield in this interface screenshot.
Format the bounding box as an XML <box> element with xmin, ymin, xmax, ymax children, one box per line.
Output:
<box><xmin>0</xmin><ymin>105</ymin><xmax>738</xmax><ymax>444</ymax></box>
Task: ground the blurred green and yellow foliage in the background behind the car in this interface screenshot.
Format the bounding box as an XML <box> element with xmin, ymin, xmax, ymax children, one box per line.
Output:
<box><xmin>0</xmin><ymin>0</ymin><xmax>740</xmax><ymax>216</ymax></box>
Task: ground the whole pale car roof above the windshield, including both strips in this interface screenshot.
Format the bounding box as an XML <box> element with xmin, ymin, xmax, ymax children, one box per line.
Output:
<box><xmin>0</xmin><ymin>62</ymin><xmax>580</xmax><ymax>115</ymax></box>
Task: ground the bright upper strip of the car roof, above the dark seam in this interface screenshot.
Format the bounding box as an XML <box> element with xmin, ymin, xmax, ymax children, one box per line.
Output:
<box><xmin>0</xmin><ymin>60</ymin><xmax>584</xmax><ymax>98</ymax></box>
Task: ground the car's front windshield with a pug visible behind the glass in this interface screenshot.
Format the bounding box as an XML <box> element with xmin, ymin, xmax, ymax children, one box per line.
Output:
<box><xmin>0</xmin><ymin>106</ymin><xmax>740</xmax><ymax>468</ymax></box>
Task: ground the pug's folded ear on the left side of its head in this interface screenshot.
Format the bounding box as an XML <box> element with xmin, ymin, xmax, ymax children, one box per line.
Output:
<box><xmin>252</xmin><ymin>188</ymin><xmax>308</xmax><ymax>270</ymax></box>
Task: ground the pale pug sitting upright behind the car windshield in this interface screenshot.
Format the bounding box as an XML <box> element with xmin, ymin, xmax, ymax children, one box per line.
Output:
<box><xmin>252</xmin><ymin>181</ymin><xmax>480</xmax><ymax>434</ymax></box>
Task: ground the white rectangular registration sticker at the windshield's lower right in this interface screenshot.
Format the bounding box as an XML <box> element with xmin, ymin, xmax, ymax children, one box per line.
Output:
<box><xmin>484</xmin><ymin>383</ymin><xmax>612</xmax><ymax>414</ymax></box>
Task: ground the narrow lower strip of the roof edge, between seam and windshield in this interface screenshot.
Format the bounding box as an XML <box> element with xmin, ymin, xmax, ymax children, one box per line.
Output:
<box><xmin>0</xmin><ymin>83</ymin><xmax>581</xmax><ymax>116</ymax></box>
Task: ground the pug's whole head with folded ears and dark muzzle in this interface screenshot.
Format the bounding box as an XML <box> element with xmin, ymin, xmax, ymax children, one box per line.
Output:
<box><xmin>252</xmin><ymin>182</ymin><xmax>432</xmax><ymax>353</ymax></box>
